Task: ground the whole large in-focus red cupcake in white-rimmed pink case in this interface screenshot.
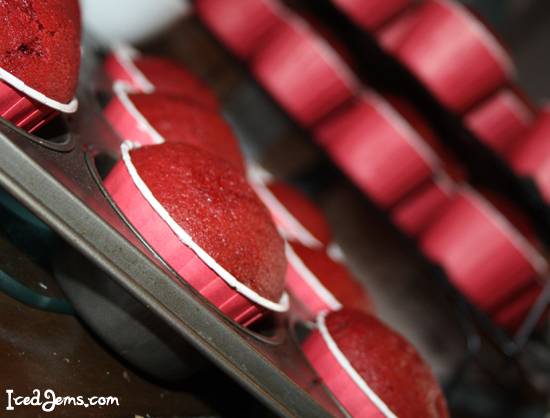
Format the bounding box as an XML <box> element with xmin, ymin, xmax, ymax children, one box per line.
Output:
<box><xmin>105</xmin><ymin>143</ymin><xmax>288</xmax><ymax>325</ymax></box>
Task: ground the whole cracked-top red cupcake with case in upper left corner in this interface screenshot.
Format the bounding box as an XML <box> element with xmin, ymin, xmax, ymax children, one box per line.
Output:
<box><xmin>0</xmin><ymin>0</ymin><xmax>80</xmax><ymax>131</ymax></box>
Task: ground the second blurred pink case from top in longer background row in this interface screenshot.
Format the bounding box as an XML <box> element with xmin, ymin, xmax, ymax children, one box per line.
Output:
<box><xmin>250</xmin><ymin>18</ymin><xmax>359</xmax><ymax>127</ymax></box>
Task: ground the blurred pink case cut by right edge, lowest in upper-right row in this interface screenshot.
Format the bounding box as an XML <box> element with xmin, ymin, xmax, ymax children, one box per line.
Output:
<box><xmin>507</xmin><ymin>105</ymin><xmax>550</xmax><ymax>202</ymax></box>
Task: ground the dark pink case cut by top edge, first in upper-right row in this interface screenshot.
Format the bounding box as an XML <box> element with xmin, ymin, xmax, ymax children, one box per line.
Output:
<box><xmin>332</xmin><ymin>0</ymin><xmax>413</xmax><ymax>32</ymax></box>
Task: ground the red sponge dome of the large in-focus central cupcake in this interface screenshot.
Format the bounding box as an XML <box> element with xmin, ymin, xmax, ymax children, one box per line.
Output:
<box><xmin>130</xmin><ymin>143</ymin><xmax>286</xmax><ymax>302</ymax></box>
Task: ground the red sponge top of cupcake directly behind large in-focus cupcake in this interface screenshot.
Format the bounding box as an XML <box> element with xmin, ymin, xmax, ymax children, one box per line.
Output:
<box><xmin>129</xmin><ymin>93</ymin><xmax>245</xmax><ymax>173</ymax></box>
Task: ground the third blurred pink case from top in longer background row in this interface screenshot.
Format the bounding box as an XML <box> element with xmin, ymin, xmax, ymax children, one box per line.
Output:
<box><xmin>314</xmin><ymin>92</ymin><xmax>441</xmax><ymax>208</ymax></box>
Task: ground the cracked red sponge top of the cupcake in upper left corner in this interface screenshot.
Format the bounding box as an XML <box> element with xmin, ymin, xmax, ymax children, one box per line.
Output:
<box><xmin>0</xmin><ymin>0</ymin><xmax>80</xmax><ymax>103</ymax></box>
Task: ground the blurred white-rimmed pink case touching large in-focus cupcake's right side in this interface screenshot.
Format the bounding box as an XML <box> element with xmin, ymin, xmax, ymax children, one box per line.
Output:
<box><xmin>247</xmin><ymin>166</ymin><xmax>324</xmax><ymax>248</ymax></box>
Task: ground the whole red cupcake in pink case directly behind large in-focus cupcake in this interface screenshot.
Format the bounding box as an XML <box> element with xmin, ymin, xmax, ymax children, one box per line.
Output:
<box><xmin>104</xmin><ymin>84</ymin><xmax>245</xmax><ymax>173</ymax></box>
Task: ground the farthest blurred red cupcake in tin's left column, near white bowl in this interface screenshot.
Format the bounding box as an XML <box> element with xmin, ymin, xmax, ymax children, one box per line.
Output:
<box><xmin>103</xmin><ymin>44</ymin><xmax>220</xmax><ymax>111</ymax></box>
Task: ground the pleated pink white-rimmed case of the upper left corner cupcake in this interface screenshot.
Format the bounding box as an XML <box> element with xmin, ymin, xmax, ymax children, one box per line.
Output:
<box><xmin>0</xmin><ymin>68</ymin><xmax>78</xmax><ymax>132</ymax></box>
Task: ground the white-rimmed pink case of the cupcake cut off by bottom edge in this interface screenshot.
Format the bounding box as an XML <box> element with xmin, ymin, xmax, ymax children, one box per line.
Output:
<box><xmin>302</xmin><ymin>313</ymin><xmax>397</xmax><ymax>418</ymax></box>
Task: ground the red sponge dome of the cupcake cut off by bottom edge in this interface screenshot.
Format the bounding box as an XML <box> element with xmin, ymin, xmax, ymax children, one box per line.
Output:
<box><xmin>326</xmin><ymin>309</ymin><xmax>449</xmax><ymax>418</ymax></box>
